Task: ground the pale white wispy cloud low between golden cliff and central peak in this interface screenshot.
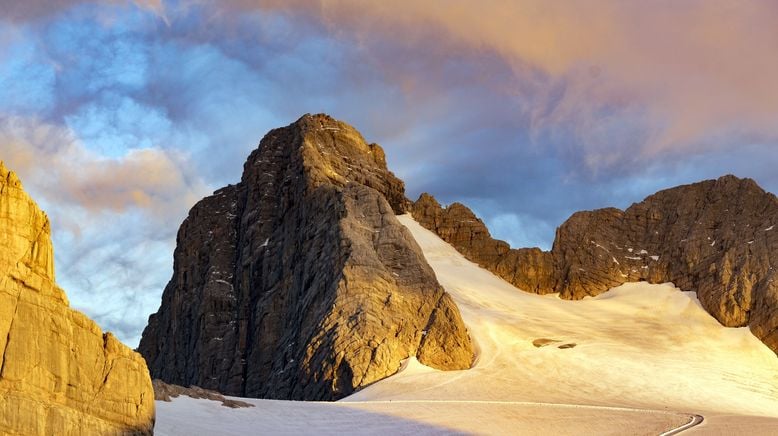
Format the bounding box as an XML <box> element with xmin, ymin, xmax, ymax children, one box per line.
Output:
<box><xmin>54</xmin><ymin>206</ymin><xmax>176</xmax><ymax>347</ymax></box>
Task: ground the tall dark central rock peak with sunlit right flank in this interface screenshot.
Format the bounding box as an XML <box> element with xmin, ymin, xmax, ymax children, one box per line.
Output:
<box><xmin>139</xmin><ymin>115</ymin><xmax>473</xmax><ymax>400</ymax></box>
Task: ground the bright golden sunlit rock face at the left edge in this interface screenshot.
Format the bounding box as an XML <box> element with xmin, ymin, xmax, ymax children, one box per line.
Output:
<box><xmin>0</xmin><ymin>162</ymin><xmax>154</xmax><ymax>435</ymax></box>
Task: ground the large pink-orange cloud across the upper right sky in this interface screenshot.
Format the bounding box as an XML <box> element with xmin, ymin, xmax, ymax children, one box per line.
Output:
<box><xmin>203</xmin><ymin>0</ymin><xmax>778</xmax><ymax>166</ymax></box>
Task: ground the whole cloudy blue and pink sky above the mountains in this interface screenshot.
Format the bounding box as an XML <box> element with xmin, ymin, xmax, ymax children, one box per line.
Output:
<box><xmin>0</xmin><ymin>0</ymin><xmax>778</xmax><ymax>346</ymax></box>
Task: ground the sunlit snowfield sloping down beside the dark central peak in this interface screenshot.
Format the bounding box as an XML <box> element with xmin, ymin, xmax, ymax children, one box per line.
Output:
<box><xmin>156</xmin><ymin>215</ymin><xmax>778</xmax><ymax>435</ymax></box>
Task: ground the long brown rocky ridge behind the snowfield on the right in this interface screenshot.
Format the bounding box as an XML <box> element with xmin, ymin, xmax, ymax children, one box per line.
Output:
<box><xmin>412</xmin><ymin>176</ymin><xmax>778</xmax><ymax>352</ymax></box>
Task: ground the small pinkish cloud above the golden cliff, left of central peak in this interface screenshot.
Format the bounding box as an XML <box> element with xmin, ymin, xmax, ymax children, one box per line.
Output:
<box><xmin>0</xmin><ymin>117</ymin><xmax>207</xmax><ymax>219</ymax></box>
